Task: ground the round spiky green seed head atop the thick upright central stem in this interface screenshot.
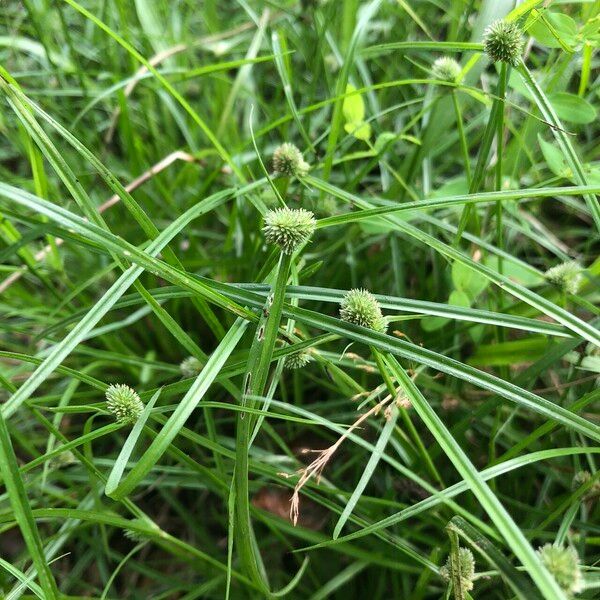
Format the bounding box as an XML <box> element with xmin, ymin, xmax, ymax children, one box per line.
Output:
<box><xmin>263</xmin><ymin>208</ymin><xmax>317</xmax><ymax>254</ymax></box>
